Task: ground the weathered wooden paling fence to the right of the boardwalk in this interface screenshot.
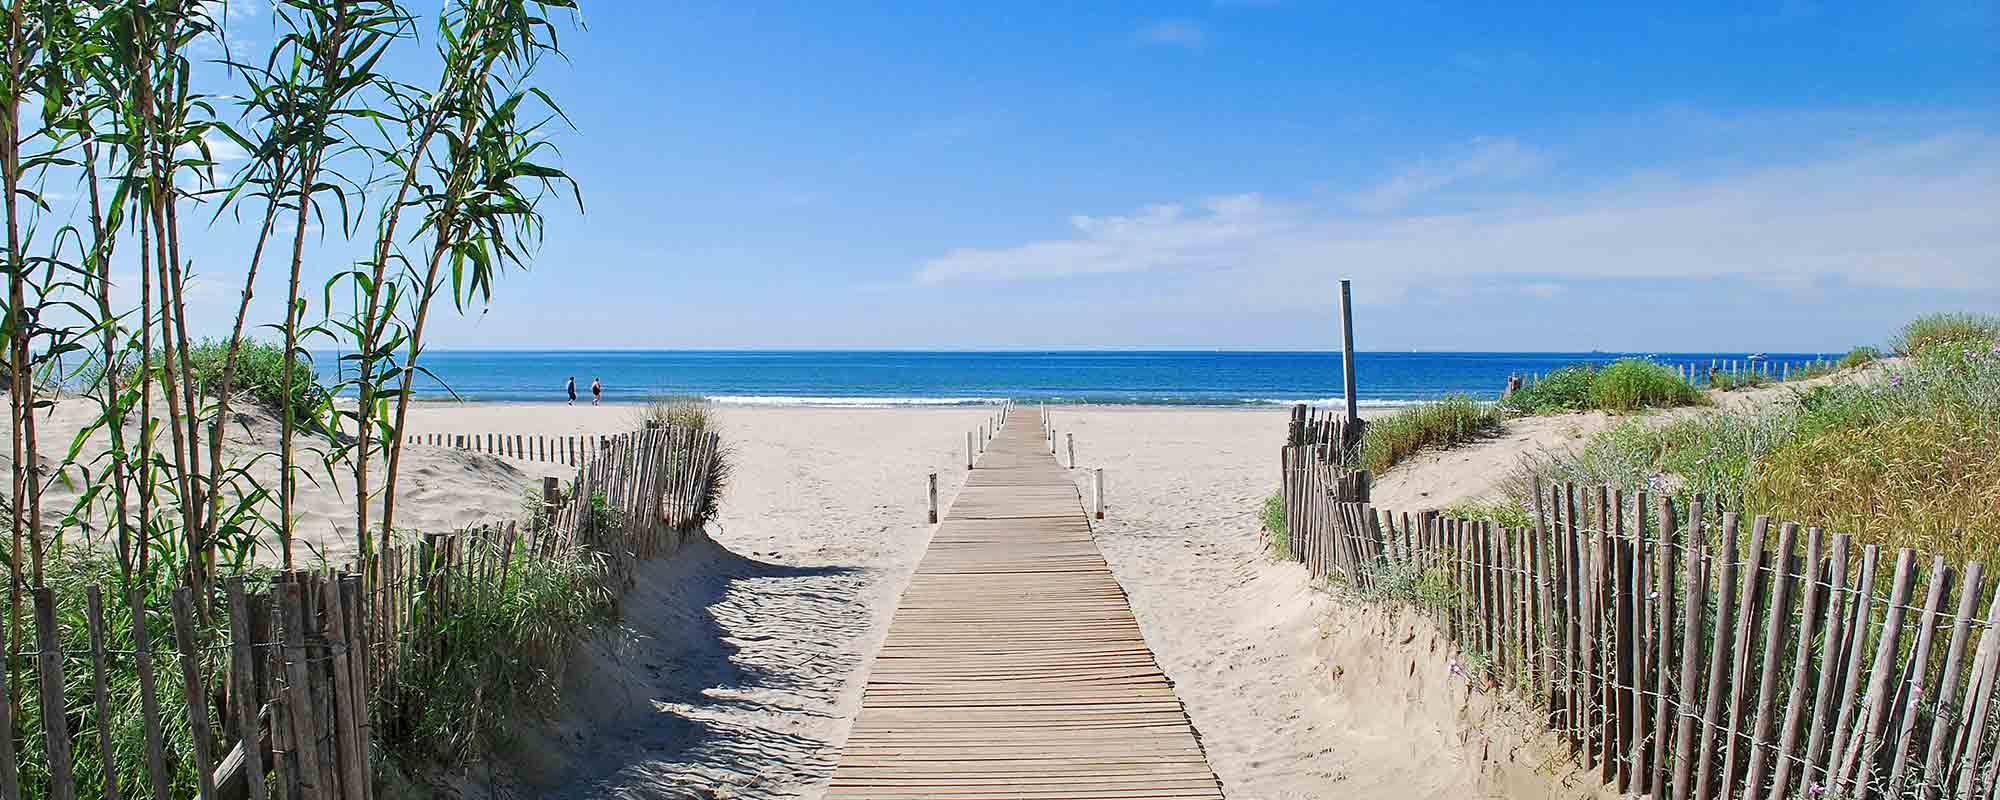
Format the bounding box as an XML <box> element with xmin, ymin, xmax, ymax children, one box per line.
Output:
<box><xmin>1282</xmin><ymin>414</ymin><xmax>2000</xmax><ymax>800</ymax></box>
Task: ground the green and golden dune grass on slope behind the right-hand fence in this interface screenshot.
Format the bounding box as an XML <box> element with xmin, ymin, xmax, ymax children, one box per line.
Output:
<box><xmin>1510</xmin><ymin>318</ymin><xmax>2000</xmax><ymax>564</ymax></box>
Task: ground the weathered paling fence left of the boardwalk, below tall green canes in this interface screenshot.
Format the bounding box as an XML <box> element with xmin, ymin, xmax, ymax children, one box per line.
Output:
<box><xmin>0</xmin><ymin>428</ymin><xmax>720</xmax><ymax>800</ymax></box>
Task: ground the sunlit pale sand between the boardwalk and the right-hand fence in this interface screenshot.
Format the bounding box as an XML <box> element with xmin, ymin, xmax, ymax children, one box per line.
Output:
<box><xmin>1054</xmin><ymin>408</ymin><xmax>1596</xmax><ymax>798</ymax></box>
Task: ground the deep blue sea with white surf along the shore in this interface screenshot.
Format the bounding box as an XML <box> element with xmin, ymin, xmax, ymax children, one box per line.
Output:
<box><xmin>316</xmin><ymin>350</ymin><xmax>1838</xmax><ymax>406</ymax></box>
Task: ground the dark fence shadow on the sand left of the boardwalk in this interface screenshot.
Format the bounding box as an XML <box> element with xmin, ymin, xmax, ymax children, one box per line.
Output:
<box><xmin>514</xmin><ymin>538</ymin><xmax>870</xmax><ymax>798</ymax></box>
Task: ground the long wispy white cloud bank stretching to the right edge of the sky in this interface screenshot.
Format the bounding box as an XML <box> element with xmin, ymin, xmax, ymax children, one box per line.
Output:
<box><xmin>914</xmin><ymin>132</ymin><xmax>2000</xmax><ymax>302</ymax></box>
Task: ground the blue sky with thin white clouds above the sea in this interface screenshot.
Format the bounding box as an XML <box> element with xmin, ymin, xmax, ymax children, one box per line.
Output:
<box><xmin>133</xmin><ymin>0</ymin><xmax>2000</xmax><ymax>352</ymax></box>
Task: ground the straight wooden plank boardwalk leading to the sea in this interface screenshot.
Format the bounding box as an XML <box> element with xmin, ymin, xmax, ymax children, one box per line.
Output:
<box><xmin>828</xmin><ymin>408</ymin><xmax>1222</xmax><ymax>800</ymax></box>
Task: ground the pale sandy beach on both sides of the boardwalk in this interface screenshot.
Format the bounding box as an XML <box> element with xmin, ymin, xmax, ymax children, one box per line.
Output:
<box><xmin>386</xmin><ymin>404</ymin><xmax>1592</xmax><ymax>798</ymax></box>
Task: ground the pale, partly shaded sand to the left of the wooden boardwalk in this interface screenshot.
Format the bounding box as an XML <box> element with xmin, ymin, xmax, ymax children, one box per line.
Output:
<box><xmin>450</xmin><ymin>406</ymin><xmax>990</xmax><ymax>798</ymax></box>
